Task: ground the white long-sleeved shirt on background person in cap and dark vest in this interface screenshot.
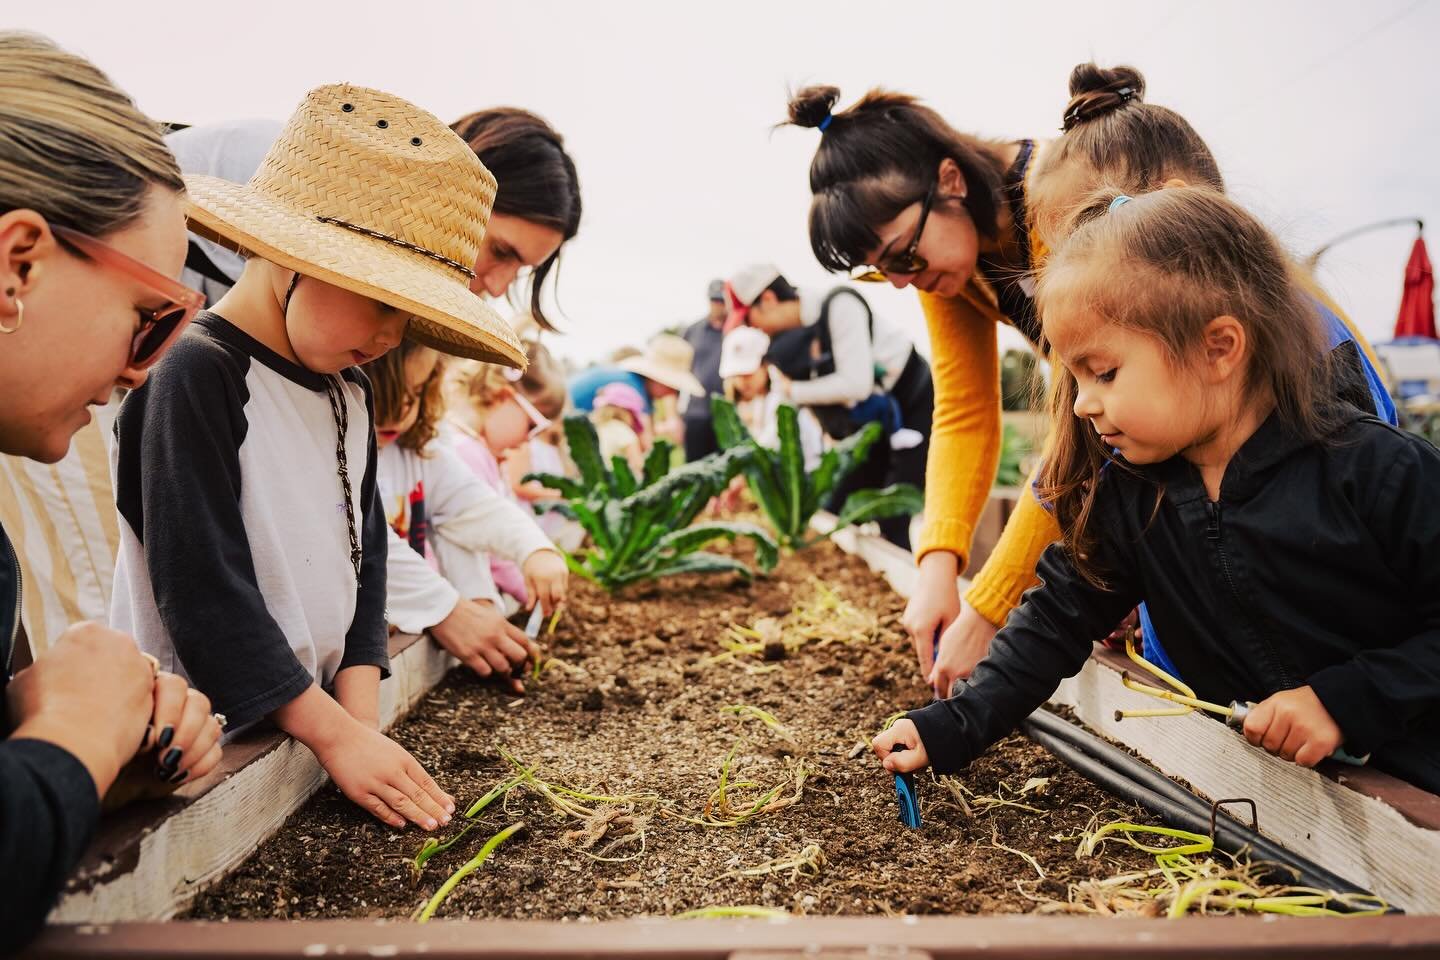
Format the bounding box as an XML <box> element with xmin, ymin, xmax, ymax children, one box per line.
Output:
<box><xmin>791</xmin><ymin>283</ymin><xmax>914</xmax><ymax>406</ymax></box>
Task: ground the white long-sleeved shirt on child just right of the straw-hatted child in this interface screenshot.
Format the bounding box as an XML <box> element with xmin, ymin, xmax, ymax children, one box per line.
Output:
<box><xmin>376</xmin><ymin>442</ymin><xmax>554</xmax><ymax>633</ymax></box>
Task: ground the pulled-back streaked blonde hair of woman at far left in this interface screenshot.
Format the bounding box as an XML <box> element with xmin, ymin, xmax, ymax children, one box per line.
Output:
<box><xmin>0</xmin><ymin>30</ymin><xmax>184</xmax><ymax>236</ymax></box>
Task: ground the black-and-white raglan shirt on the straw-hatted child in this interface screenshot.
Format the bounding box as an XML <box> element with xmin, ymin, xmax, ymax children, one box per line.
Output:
<box><xmin>111</xmin><ymin>312</ymin><xmax>389</xmax><ymax>733</ymax></box>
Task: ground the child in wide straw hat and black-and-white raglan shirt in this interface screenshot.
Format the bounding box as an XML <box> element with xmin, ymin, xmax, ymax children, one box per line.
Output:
<box><xmin>112</xmin><ymin>85</ymin><xmax>524</xmax><ymax>830</ymax></box>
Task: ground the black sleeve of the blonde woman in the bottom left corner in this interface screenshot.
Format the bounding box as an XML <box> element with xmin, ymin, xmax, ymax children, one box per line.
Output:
<box><xmin>0</xmin><ymin>740</ymin><xmax>99</xmax><ymax>957</ymax></box>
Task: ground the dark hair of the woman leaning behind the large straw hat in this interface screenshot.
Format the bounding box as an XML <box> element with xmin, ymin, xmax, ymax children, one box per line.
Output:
<box><xmin>451</xmin><ymin>107</ymin><xmax>580</xmax><ymax>331</ymax></box>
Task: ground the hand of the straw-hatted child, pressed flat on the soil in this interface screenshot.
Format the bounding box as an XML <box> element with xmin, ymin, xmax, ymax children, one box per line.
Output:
<box><xmin>315</xmin><ymin>721</ymin><xmax>455</xmax><ymax>830</ymax></box>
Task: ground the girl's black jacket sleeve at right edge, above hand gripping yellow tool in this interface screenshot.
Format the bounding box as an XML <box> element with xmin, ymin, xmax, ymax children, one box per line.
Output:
<box><xmin>1309</xmin><ymin>430</ymin><xmax>1440</xmax><ymax>754</ymax></box>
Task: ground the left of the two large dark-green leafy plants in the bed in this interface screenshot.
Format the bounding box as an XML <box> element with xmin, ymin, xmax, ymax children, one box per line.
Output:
<box><xmin>524</xmin><ymin>416</ymin><xmax>779</xmax><ymax>590</ymax></box>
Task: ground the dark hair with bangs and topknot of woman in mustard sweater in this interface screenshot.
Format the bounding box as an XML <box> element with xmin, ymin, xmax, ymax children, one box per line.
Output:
<box><xmin>788</xmin><ymin>86</ymin><xmax>1005</xmax><ymax>271</ymax></box>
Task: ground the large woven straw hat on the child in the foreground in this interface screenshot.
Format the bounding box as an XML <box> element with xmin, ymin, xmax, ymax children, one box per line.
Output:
<box><xmin>177</xmin><ymin>83</ymin><xmax>526</xmax><ymax>367</ymax></box>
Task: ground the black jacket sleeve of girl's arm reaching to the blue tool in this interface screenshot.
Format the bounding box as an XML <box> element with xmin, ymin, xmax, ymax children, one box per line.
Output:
<box><xmin>907</xmin><ymin>489</ymin><xmax>1140</xmax><ymax>774</ymax></box>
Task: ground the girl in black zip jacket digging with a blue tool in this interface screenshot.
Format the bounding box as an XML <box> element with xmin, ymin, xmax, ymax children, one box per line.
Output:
<box><xmin>873</xmin><ymin>187</ymin><xmax>1440</xmax><ymax>792</ymax></box>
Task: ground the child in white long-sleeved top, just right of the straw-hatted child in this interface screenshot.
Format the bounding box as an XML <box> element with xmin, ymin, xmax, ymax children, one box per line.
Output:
<box><xmin>364</xmin><ymin>343</ymin><xmax>569</xmax><ymax>692</ymax></box>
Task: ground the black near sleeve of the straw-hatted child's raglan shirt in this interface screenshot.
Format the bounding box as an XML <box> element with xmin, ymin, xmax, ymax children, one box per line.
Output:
<box><xmin>115</xmin><ymin>335</ymin><xmax>314</xmax><ymax>727</ymax></box>
